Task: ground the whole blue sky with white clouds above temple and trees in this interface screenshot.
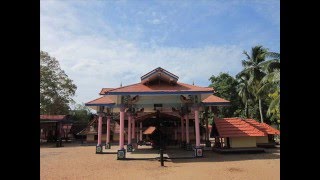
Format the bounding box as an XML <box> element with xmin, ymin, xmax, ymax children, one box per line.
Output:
<box><xmin>40</xmin><ymin>0</ymin><xmax>280</xmax><ymax>106</ymax></box>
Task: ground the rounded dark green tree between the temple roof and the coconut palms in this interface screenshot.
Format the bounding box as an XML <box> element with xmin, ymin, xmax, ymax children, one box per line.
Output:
<box><xmin>209</xmin><ymin>73</ymin><xmax>242</xmax><ymax>117</ymax></box>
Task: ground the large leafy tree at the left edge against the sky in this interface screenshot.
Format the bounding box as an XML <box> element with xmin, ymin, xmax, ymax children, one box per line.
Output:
<box><xmin>40</xmin><ymin>51</ymin><xmax>77</xmax><ymax>114</ymax></box>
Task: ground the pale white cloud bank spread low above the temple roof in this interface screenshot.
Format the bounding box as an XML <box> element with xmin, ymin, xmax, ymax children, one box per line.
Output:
<box><xmin>40</xmin><ymin>2</ymin><xmax>243</xmax><ymax>103</ymax></box>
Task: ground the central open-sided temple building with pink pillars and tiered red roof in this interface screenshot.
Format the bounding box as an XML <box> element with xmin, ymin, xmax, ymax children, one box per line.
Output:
<box><xmin>85</xmin><ymin>67</ymin><xmax>229</xmax><ymax>159</ymax></box>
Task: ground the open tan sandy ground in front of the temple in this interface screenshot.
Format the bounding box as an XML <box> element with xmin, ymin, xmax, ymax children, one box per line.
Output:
<box><xmin>40</xmin><ymin>145</ymin><xmax>280</xmax><ymax>180</ymax></box>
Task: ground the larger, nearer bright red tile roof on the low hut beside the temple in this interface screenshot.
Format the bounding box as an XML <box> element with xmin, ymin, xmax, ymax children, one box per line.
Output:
<box><xmin>215</xmin><ymin>118</ymin><xmax>266</xmax><ymax>137</ymax></box>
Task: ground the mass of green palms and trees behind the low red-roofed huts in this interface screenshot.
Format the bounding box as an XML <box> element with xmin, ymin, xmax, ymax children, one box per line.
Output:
<box><xmin>206</xmin><ymin>46</ymin><xmax>280</xmax><ymax>125</ymax></box>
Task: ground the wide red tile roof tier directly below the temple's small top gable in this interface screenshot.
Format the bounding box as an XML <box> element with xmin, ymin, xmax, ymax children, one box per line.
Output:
<box><xmin>107</xmin><ymin>82</ymin><xmax>213</xmax><ymax>94</ymax></box>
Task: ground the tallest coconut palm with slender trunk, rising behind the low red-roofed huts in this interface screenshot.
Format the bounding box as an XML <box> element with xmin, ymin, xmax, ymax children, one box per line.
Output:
<box><xmin>238</xmin><ymin>46</ymin><xmax>268</xmax><ymax>122</ymax></box>
